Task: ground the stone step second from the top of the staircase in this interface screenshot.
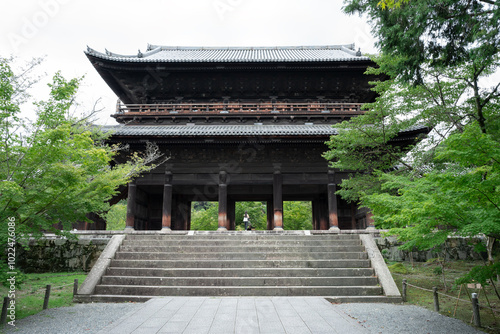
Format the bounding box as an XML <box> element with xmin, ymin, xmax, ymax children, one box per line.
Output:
<box><xmin>122</xmin><ymin>239</ymin><xmax>361</xmax><ymax>247</ymax></box>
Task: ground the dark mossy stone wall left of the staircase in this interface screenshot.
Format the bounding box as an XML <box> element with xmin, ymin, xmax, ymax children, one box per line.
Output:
<box><xmin>16</xmin><ymin>235</ymin><xmax>111</xmax><ymax>273</ymax></box>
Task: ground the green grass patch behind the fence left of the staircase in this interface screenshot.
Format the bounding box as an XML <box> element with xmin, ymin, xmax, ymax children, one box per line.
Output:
<box><xmin>0</xmin><ymin>272</ymin><xmax>87</xmax><ymax>320</ymax></box>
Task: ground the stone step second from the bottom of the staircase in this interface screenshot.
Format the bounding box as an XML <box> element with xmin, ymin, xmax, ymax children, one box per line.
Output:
<box><xmin>101</xmin><ymin>276</ymin><xmax>378</xmax><ymax>286</ymax></box>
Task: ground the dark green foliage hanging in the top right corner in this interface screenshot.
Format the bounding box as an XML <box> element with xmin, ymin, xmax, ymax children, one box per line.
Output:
<box><xmin>344</xmin><ymin>0</ymin><xmax>500</xmax><ymax>82</ymax></box>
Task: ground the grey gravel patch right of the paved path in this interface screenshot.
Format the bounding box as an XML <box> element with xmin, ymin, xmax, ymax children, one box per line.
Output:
<box><xmin>335</xmin><ymin>304</ymin><xmax>484</xmax><ymax>334</ymax></box>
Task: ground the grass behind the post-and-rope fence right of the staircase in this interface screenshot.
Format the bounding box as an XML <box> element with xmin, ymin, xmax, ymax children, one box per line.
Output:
<box><xmin>388</xmin><ymin>261</ymin><xmax>500</xmax><ymax>333</ymax></box>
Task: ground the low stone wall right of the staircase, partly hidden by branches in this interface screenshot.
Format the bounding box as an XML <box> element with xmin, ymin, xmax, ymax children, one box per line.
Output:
<box><xmin>375</xmin><ymin>237</ymin><xmax>487</xmax><ymax>262</ymax></box>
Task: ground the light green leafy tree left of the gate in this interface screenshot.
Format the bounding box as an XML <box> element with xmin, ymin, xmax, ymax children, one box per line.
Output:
<box><xmin>0</xmin><ymin>59</ymin><xmax>159</xmax><ymax>237</ymax></box>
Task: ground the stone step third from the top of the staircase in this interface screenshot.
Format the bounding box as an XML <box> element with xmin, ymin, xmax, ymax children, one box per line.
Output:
<box><xmin>115</xmin><ymin>251</ymin><xmax>368</xmax><ymax>260</ymax></box>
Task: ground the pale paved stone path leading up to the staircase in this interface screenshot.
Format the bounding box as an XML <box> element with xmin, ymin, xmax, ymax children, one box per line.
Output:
<box><xmin>99</xmin><ymin>297</ymin><xmax>367</xmax><ymax>334</ymax></box>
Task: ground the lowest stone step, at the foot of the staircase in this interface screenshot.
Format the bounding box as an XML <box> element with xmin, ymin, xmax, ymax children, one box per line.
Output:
<box><xmin>95</xmin><ymin>285</ymin><xmax>382</xmax><ymax>296</ymax></box>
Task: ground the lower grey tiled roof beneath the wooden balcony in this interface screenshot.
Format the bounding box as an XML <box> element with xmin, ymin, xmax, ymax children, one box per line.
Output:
<box><xmin>99</xmin><ymin>125</ymin><xmax>337</xmax><ymax>137</ymax></box>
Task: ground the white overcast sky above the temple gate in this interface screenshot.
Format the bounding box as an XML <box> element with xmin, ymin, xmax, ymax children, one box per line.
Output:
<box><xmin>0</xmin><ymin>0</ymin><xmax>376</xmax><ymax>124</ymax></box>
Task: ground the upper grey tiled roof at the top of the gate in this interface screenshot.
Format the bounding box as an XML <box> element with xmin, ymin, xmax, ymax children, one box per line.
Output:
<box><xmin>86</xmin><ymin>44</ymin><xmax>369</xmax><ymax>62</ymax></box>
